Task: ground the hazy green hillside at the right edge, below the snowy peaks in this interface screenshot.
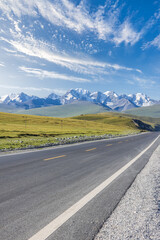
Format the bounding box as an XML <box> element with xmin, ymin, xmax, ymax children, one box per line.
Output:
<box><xmin>125</xmin><ymin>104</ymin><xmax>160</xmax><ymax>118</ymax></box>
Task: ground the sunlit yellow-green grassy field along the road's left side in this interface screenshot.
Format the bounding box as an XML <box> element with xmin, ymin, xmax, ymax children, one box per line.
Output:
<box><xmin>0</xmin><ymin>113</ymin><xmax>140</xmax><ymax>149</ymax></box>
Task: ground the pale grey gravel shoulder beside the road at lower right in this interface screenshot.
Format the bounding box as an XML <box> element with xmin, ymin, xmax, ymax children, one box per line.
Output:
<box><xmin>94</xmin><ymin>146</ymin><xmax>160</xmax><ymax>240</ymax></box>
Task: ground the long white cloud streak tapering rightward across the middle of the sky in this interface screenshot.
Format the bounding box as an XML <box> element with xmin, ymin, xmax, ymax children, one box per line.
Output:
<box><xmin>0</xmin><ymin>30</ymin><xmax>141</xmax><ymax>75</ymax></box>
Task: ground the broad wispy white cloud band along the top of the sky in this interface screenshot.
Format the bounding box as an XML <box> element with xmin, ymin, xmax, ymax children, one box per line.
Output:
<box><xmin>0</xmin><ymin>0</ymin><xmax>140</xmax><ymax>45</ymax></box>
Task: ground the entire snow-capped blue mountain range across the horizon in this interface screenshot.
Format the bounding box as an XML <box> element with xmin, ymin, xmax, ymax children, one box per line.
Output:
<box><xmin>0</xmin><ymin>88</ymin><xmax>160</xmax><ymax>112</ymax></box>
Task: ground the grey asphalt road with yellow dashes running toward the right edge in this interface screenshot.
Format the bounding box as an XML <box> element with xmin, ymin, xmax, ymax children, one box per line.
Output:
<box><xmin>0</xmin><ymin>133</ymin><xmax>160</xmax><ymax>240</ymax></box>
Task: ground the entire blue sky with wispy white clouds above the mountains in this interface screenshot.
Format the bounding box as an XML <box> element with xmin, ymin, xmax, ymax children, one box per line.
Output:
<box><xmin>0</xmin><ymin>0</ymin><xmax>160</xmax><ymax>99</ymax></box>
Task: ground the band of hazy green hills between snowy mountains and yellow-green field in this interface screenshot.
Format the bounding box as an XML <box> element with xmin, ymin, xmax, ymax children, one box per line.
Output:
<box><xmin>15</xmin><ymin>101</ymin><xmax>160</xmax><ymax>124</ymax></box>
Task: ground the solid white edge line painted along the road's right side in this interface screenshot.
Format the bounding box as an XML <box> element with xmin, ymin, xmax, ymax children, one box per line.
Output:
<box><xmin>28</xmin><ymin>135</ymin><xmax>160</xmax><ymax>240</ymax></box>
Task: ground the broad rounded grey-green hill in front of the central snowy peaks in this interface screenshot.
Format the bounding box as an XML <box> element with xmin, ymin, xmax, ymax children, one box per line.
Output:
<box><xmin>16</xmin><ymin>101</ymin><xmax>109</xmax><ymax>117</ymax></box>
